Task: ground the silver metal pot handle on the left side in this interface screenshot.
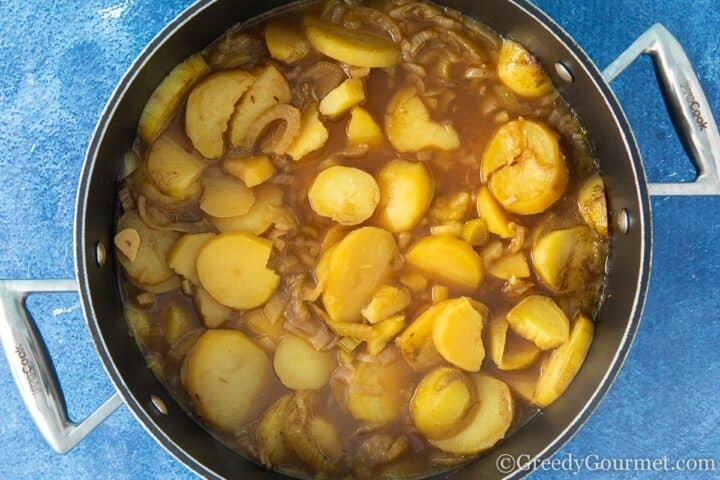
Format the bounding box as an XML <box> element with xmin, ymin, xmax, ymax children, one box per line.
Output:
<box><xmin>0</xmin><ymin>280</ymin><xmax>122</xmax><ymax>453</ymax></box>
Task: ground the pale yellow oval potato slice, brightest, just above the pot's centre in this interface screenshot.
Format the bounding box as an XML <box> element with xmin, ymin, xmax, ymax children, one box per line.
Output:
<box><xmin>308</xmin><ymin>165</ymin><xmax>380</xmax><ymax>225</ymax></box>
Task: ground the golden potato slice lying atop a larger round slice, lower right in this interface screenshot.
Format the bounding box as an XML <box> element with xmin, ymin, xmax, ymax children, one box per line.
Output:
<box><xmin>410</xmin><ymin>367</ymin><xmax>477</xmax><ymax>439</ymax></box>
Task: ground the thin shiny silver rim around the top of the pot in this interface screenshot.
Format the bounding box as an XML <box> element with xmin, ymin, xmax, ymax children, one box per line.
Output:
<box><xmin>73</xmin><ymin>0</ymin><xmax>652</xmax><ymax>480</ymax></box>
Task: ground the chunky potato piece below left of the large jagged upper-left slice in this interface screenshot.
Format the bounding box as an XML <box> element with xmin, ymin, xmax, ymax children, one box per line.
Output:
<box><xmin>146</xmin><ymin>136</ymin><xmax>206</xmax><ymax>199</ymax></box>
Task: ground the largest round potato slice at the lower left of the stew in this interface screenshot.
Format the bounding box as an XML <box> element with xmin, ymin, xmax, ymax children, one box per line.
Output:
<box><xmin>181</xmin><ymin>330</ymin><xmax>273</xmax><ymax>432</ymax></box>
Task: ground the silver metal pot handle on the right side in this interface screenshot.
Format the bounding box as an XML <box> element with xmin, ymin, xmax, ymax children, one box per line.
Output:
<box><xmin>603</xmin><ymin>23</ymin><xmax>720</xmax><ymax>195</ymax></box>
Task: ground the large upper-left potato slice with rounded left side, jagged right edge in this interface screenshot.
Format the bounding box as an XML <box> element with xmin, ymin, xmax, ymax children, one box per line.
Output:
<box><xmin>185</xmin><ymin>70</ymin><xmax>255</xmax><ymax>159</ymax></box>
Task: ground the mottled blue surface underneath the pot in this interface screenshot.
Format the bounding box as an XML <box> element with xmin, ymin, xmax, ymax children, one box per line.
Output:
<box><xmin>0</xmin><ymin>0</ymin><xmax>720</xmax><ymax>480</ymax></box>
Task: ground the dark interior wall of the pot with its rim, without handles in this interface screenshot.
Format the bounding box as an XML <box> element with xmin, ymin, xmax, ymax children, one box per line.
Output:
<box><xmin>77</xmin><ymin>0</ymin><xmax>650</xmax><ymax>479</ymax></box>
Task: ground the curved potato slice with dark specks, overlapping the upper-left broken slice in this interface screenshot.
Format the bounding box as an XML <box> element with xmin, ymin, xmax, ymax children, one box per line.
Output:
<box><xmin>228</xmin><ymin>64</ymin><xmax>292</xmax><ymax>147</ymax></box>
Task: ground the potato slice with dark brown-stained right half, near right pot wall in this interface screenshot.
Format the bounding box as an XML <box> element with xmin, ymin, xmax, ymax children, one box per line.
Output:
<box><xmin>532</xmin><ymin>226</ymin><xmax>604</xmax><ymax>293</ymax></box>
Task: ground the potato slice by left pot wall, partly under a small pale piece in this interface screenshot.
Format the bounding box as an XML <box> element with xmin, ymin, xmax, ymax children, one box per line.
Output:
<box><xmin>117</xmin><ymin>210</ymin><xmax>180</xmax><ymax>286</ymax></box>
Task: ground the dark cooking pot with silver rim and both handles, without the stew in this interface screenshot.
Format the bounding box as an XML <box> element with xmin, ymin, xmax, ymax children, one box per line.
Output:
<box><xmin>0</xmin><ymin>0</ymin><xmax>720</xmax><ymax>479</ymax></box>
